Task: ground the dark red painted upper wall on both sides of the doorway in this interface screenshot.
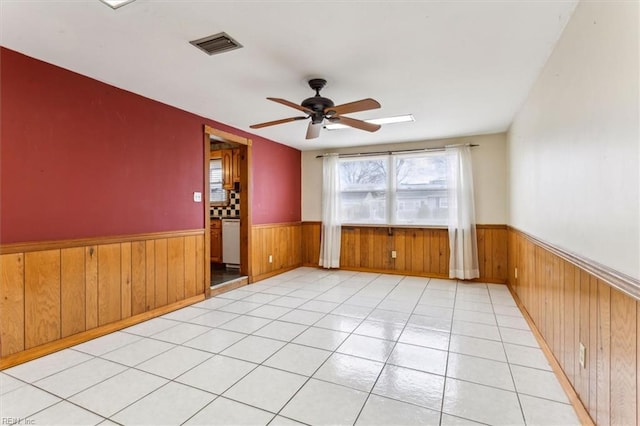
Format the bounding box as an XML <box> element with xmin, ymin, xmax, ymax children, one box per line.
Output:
<box><xmin>0</xmin><ymin>48</ymin><xmax>300</xmax><ymax>243</ymax></box>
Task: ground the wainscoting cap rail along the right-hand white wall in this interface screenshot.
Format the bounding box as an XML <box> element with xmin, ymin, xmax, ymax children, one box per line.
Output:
<box><xmin>509</xmin><ymin>226</ymin><xmax>640</xmax><ymax>300</ymax></box>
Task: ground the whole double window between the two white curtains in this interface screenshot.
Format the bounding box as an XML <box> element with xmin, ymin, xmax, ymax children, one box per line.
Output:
<box><xmin>339</xmin><ymin>152</ymin><xmax>448</xmax><ymax>225</ymax></box>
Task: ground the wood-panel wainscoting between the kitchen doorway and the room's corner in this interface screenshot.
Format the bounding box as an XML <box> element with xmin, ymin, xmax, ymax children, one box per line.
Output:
<box><xmin>249</xmin><ymin>222</ymin><xmax>302</xmax><ymax>282</ymax></box>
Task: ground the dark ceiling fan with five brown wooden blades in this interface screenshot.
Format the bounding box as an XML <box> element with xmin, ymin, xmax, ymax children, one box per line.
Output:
<box><xmin>249</xmin><ymin>78</ymin><xmax>380</xmax><ymax>139</ymax></box>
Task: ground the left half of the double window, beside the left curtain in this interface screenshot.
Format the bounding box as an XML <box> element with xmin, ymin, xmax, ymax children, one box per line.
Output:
<box><xmin>339</xmin><ymin>157</ymin><xmax>387</xmax><ymax>223</ymax></box>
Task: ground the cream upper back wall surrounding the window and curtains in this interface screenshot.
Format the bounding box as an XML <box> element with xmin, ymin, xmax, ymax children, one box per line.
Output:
<box><xmin>302</xmin><ymin>133</ymin><xmax>507</xmax><ymax>224</ymax></box>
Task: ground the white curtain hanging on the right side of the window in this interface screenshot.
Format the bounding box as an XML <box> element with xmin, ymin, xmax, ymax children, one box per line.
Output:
<box><xmin>446</xmin><ymin>145</ymin><xmax>480</xmax><ymax>279</ymax></box>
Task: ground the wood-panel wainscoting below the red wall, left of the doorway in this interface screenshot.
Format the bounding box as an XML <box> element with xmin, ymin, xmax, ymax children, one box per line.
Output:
<box><xmin>0</xmin><ymin>229</ymin><xmax>208</xmax><ymax>366</ymax></box>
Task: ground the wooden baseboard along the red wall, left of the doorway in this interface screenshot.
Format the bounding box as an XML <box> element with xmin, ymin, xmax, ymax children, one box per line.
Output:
<box><xmin>0</xmin><ymin>294</ymin><xmax>204</xmax><ymax>371</ymax></box>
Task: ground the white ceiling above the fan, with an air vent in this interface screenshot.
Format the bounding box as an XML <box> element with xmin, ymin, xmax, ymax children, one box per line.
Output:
<box><xmin>0</xmin><ymin>0</ymin><xmax>577</xmax><ymax>150</ymax></box>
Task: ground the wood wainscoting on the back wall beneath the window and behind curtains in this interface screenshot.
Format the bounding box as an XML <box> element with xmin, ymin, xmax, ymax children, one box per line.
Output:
<box><xmin>302</xmin><ymin>222</ymin><xmax>507</xmax><ymax>283</ymax></box>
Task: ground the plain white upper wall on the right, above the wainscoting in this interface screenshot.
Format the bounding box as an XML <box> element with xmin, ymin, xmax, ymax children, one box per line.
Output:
<box><xmin>508</xmin><ymin>1</ymin><xmax>640</xmax><ymax>279</ymax></box>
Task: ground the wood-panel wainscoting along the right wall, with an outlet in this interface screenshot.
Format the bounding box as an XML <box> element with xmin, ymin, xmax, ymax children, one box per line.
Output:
<box><xmin>508</xmin><ymin>229</ymin><xmax>640</xmax><ymax>425</ymax></box>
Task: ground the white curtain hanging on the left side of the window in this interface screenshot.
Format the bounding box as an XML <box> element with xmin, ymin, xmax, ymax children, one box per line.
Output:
<box><xmin>319</xmin><ymin>154</ymin><xmax>342</xmax><ymax>268</ymax></box>
